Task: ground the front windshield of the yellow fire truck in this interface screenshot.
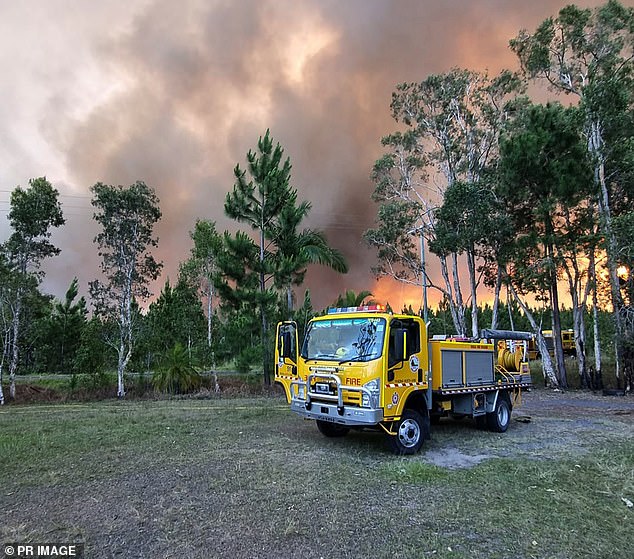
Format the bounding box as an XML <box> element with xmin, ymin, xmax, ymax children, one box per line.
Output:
<box><xmin>301</xmin><ymin>317</ymin><xmax>385</xmax><ymax>363</ymax></box>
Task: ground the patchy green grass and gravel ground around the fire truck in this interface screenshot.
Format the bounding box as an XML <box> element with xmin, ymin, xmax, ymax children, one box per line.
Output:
<box><xmin>0</xmin><ymin>390</ymin><xmax>634</xmax><ymax>559</ymax></box>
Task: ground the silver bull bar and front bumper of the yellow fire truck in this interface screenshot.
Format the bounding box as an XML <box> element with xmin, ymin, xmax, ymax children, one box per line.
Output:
<box><xmin>291</xmin><ymin>373</ymin><xmax>383</xmax><ymax>427</ymax></box>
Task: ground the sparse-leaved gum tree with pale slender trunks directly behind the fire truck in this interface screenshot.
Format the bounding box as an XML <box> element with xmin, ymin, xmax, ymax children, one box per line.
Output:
<box><xmin>366</xmin><ymin>69</ymin><xmax>523</xmax><ymax>335</ymax></box>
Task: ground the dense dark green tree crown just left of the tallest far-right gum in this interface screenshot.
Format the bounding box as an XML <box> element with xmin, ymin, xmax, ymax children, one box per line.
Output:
<box><xmin>497</xmin><ymin>104</ymin><xmax>594</xmax><ymax>292</ymax></box>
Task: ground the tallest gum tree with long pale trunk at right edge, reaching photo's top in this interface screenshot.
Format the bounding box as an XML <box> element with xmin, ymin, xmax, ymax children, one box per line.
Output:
<box><xmin>511</xmin><ymin>0</ymin><xmax>634</xmax><ymax>384</ymax></box>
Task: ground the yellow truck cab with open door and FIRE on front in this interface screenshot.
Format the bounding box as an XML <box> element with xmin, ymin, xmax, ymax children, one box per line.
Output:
<box><xmin>275</xmin><ymin>305</ymin><xmax>429</xmax><ymax>453</ymax></box>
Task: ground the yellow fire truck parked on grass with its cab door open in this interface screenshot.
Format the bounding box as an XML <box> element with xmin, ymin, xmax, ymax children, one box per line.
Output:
<box><xmin>275</xmin><ymin>305</ymin><xmax>531</xmax><ymax>454</ymax></box>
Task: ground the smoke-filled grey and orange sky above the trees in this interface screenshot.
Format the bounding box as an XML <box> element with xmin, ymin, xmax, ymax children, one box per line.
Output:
<box><xmin>0</xmin><ymin>0</ymin><xmax>634</xmax><ymax>308</ymax></box>
